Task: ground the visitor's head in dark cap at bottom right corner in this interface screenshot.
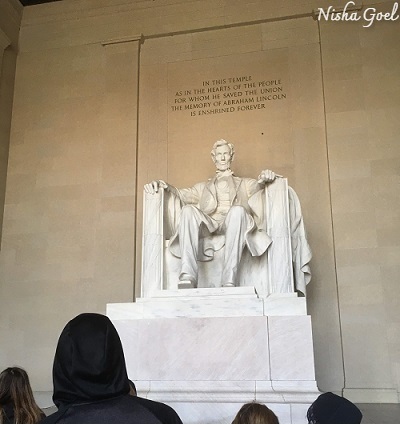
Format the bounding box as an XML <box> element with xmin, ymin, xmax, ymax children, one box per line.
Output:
<box><xmin>307</xmin><ymin>392</ymin><xmax>362</xmax><ymax>424</ymax></box>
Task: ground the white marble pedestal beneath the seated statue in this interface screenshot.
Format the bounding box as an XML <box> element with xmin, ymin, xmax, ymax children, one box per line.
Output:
<box><xmin>107</xmin><ymin>287</ymin><xmax>319</xmax><ymax>424</ymax></box>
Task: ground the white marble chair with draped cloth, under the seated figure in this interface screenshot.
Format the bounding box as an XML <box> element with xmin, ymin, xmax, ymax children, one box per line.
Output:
<box><xmin>141</xmin><ymin>178</ymin><xmax>311</xmax><ymax>298</ymax></box>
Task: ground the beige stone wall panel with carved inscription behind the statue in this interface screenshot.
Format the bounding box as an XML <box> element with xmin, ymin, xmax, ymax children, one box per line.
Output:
<box><xmin>137</xmin><ymin>18</ymin><xmax>343</xmax><ymax>391</ymax></box>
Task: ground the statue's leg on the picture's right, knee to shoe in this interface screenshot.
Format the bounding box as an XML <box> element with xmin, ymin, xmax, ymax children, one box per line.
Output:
<box><xmin>221</xmin><ymin>206</ymin><xmax>251</xmax><ymax>287</ymax></box>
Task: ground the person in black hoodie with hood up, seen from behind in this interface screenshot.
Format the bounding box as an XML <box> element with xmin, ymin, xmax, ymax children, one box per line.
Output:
<box><xmin>41</xmin><ymin>313</ymin><xmax>182</xmax><ymax>424</ymax></box>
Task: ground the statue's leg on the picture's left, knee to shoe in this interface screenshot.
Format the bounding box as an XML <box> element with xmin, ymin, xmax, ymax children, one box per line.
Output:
<box><xmin>178</xmin><ymin>205</ymin><xmax>202</xmax><ymax>288</ymax></box>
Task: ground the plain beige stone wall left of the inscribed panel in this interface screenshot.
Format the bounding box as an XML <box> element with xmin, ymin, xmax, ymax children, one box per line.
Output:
<box><xmin>0</xmin><ymin>35</ymin><xmax>139</xmax><ymax>390</ymax></box>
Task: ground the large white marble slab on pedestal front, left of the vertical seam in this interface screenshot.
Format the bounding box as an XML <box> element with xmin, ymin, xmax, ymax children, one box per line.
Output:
<box><xmin>114</xmin><ymin>317</ymin><xmax>270</xmax><ymax>381</ymax></box>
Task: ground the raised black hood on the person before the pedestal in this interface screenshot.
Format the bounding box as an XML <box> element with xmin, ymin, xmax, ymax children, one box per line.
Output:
<box><xmin>53</xmin><ymin>313</ymin><xmax>129</xmax><ymax>407</ymax></box>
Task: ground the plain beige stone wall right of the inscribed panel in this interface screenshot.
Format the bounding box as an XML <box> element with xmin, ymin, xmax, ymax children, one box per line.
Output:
<box><xmin>321</xmin><ymin>2</ymin><xmax>400</xmax><ymax>402</ymax></box>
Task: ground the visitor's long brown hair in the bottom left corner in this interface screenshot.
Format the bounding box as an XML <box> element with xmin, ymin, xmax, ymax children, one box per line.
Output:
<box><xmin>0</xmin><ymin>367</ymin><xmax>43</xmax><ymax>424</ymax></box>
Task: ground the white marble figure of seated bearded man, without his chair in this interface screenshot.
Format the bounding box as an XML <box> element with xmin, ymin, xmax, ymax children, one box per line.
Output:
<box><xmin>144</xmin><ymin>140</ymin><xmax>279</xmax><ymax>288</ymax></box>
